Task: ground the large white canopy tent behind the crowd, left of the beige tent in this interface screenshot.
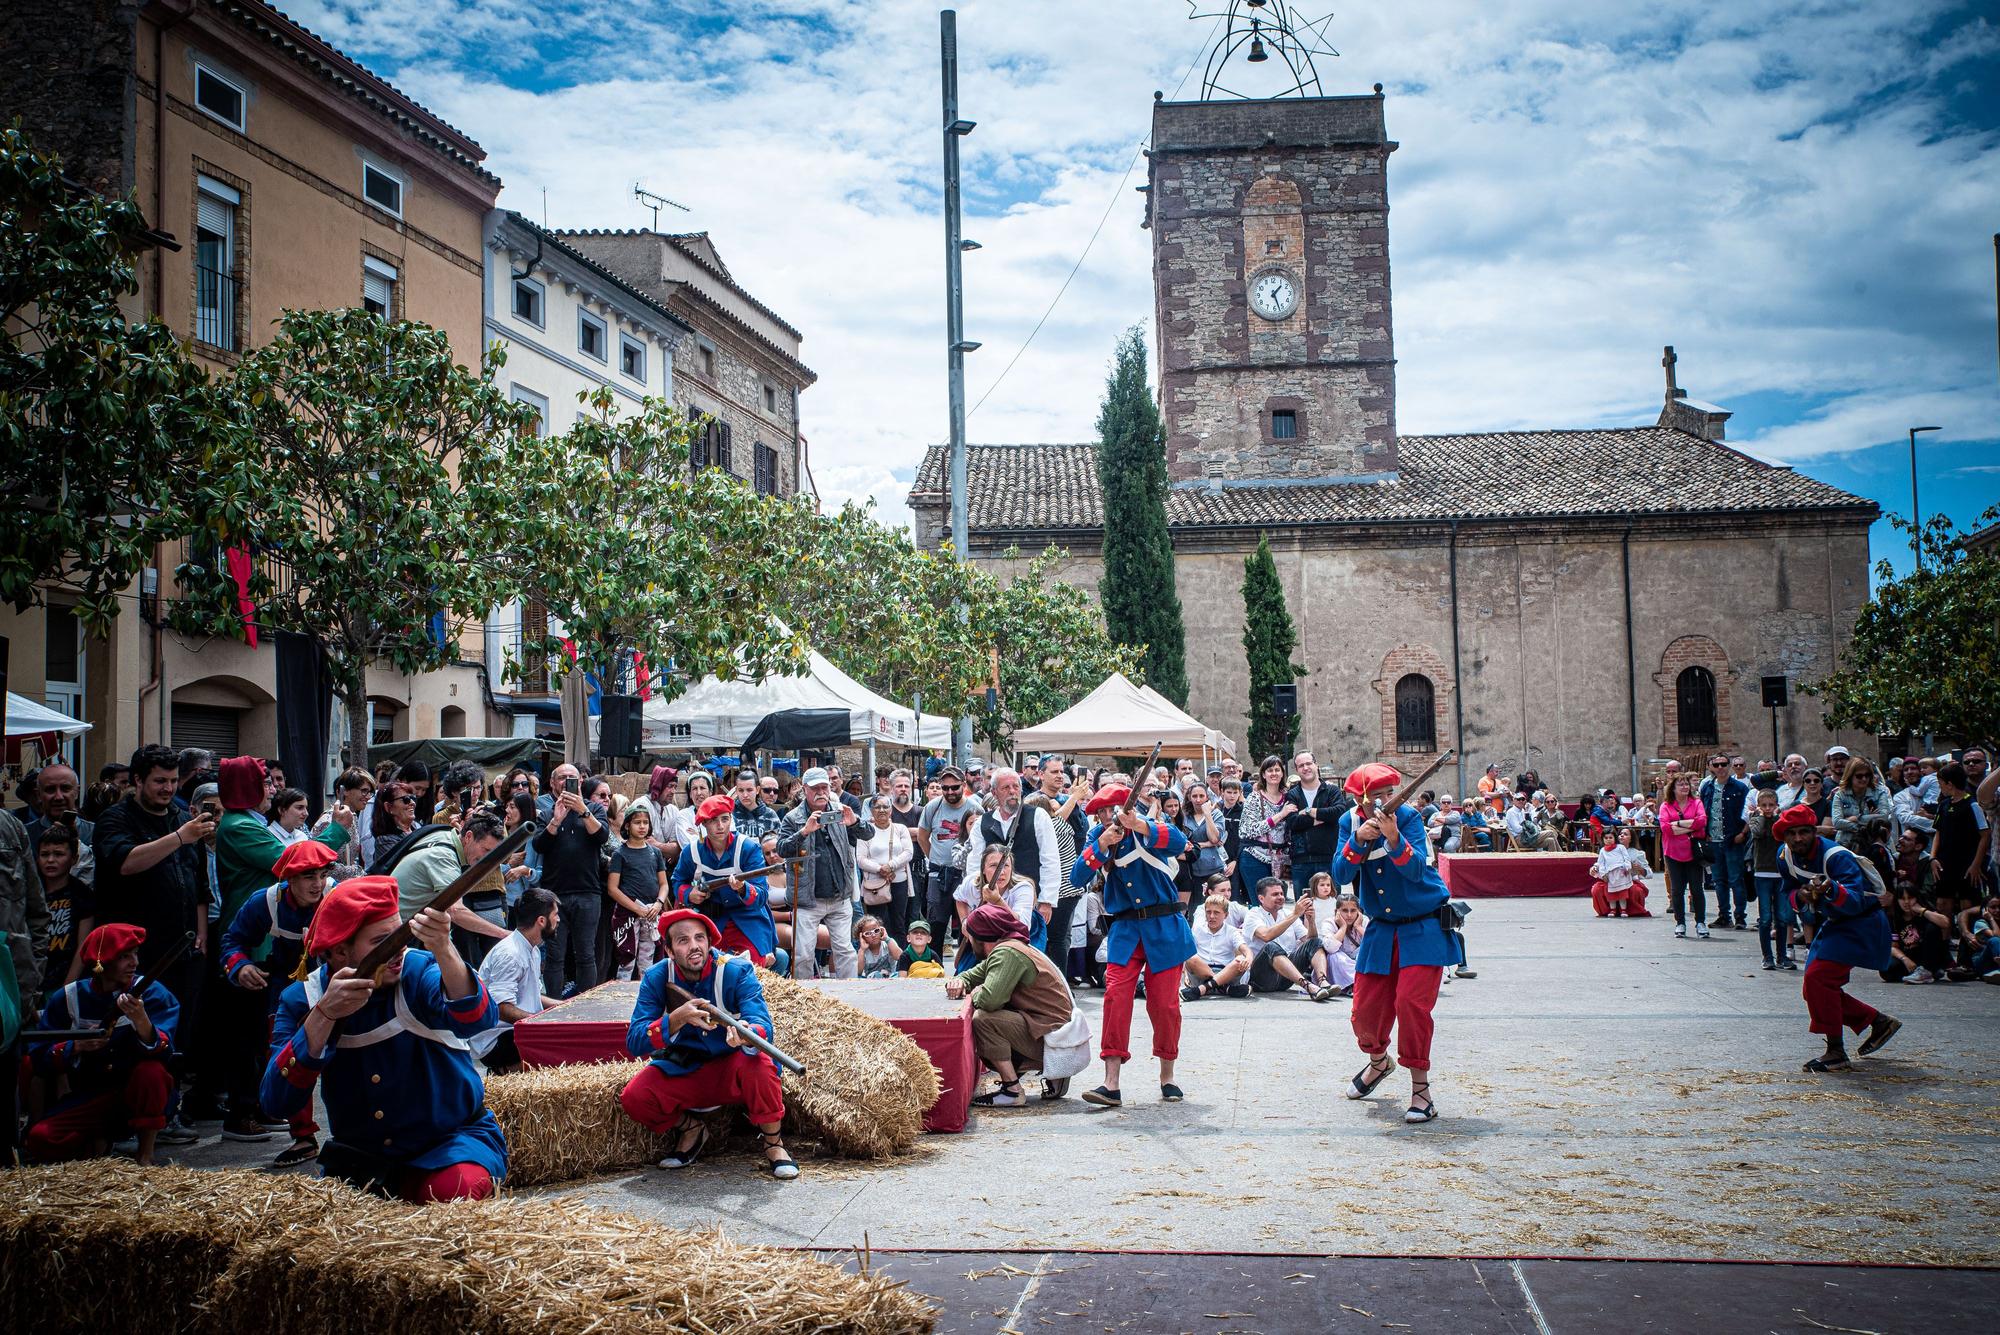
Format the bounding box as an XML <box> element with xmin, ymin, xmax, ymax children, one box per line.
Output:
<box><xmin>636</xmin><ymin>650</ymin><xmax>952</xmax><ymax>751</ymax></box>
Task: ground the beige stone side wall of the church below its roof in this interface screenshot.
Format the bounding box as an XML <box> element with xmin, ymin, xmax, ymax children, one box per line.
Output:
<box><xmin>956</xmin><ymin>516</ymin><xmax>1874</xmax><ymax>799</ymax></box>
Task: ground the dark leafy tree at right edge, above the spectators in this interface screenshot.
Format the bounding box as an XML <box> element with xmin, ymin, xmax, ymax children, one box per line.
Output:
<box><xmin>1800</xmin><ymin>508</ymin><xmax>2000</xmax><ymax>743</ymax></box>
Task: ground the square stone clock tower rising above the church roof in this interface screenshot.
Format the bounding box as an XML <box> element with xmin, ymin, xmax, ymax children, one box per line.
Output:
<box><xmin>1146</xmin><ymin>90</ymin><xmax>1396</xmax><ymax>482</ymax></box>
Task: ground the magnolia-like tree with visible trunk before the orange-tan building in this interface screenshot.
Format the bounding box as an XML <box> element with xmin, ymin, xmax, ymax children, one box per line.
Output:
<box><xmin>174</xmin><ymin>308</ymin><xmax>534</xmax><ymax>765</ymax></box>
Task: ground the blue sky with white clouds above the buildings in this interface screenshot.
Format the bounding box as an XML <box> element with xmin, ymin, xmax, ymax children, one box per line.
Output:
<box><xmin>290</xmin><ymin>0</ymin><xmax>2000</xmax><ymax>568</ymax></box>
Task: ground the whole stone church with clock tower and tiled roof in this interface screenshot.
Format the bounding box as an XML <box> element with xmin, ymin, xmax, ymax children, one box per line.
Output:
<box><xmin>910</xmin><ymin>88</ymin><xmax>1878</xmax><ymax>799</ymax></box>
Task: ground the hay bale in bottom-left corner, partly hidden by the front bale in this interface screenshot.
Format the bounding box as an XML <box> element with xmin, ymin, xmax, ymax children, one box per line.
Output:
<box><xmin>0</xmin><ymin>1159</ymin><xmax>410</xmax><ymax>1335</ymax></box>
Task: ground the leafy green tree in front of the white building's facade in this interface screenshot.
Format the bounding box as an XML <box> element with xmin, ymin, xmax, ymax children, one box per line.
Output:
<box><xmin>492</xmin><ymin>388</ymin><xmax>824</xmax><ymax>735</ymax></box>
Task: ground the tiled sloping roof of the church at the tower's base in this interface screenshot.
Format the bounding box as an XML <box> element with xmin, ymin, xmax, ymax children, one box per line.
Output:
<box><xmin>910</xmin><ymin>426</ymin><xmax>1876</xmax><ymax>530</ymax></box>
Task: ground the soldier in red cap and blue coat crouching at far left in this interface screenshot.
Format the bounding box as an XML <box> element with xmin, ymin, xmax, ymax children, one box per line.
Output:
<box><xmin>24</xmin><ymin>923</ymin><xmax>180</xmax><ymax>1163</ymax></box>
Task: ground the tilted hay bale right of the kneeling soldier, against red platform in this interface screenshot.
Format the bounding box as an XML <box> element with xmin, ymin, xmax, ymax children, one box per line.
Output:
<box><xmin>758</xmin><ymin>971</ymin><xmax>940</xmax><ymax>1159</ymax></box>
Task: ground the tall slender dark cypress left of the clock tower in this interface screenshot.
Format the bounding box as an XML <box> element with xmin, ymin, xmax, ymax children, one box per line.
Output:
<box><xmin>1098</xmin><ymin>324</ymin><xmax>1188</xmax><ymax>705</ymax></box>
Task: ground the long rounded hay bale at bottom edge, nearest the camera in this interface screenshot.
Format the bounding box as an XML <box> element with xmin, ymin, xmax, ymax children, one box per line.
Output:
<box><xmin>214</xmin><ymin>1201</ymin><xmax>936</xmax><ymax>1335</ymax></box>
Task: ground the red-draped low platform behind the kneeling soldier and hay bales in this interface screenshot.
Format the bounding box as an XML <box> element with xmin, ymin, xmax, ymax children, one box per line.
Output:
<box><xmin>514</xmin><ymin>977</ymin><xmax>978</xmax><ymax>1131</ymax></box>
